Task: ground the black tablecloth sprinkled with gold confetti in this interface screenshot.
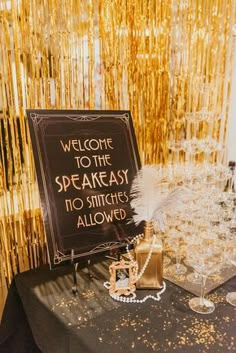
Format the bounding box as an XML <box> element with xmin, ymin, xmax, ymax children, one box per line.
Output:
<box><xmin>0</xmin><ymin>261</ymin><xmax>236</xmax><ymax>353</ymax></box>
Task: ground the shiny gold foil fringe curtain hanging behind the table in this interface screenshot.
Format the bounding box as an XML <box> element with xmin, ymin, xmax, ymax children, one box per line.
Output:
<box><xmin>0</xmin><ymin>0</ymin><xmax>235</xmax><ymax>314</ymax></box>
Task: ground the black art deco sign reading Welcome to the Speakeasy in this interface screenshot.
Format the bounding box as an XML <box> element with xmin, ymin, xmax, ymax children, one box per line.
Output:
<box><xmin>27</xmin><ymin>110</ymin><xmax>140</xmax><ymax>267</ymax></box>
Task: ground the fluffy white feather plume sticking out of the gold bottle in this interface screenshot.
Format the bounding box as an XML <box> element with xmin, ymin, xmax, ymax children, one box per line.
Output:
<box><xmin>130</xmin><ymin>165</ymin><xmax>191</xmax><ymax>225</ymax></box>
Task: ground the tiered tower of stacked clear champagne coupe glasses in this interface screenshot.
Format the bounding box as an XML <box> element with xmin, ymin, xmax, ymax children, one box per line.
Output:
<box><xmin>160</xmin><ymin>85</ymin><xmax>236</xmax><ymax>314</ymax></box>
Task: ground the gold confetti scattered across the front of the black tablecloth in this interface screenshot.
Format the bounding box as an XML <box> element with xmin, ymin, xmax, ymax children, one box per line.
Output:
<box><xmin>68</xmin><ymin>282</ymin><xmax>234</xmax><ymax>353</ymax></box>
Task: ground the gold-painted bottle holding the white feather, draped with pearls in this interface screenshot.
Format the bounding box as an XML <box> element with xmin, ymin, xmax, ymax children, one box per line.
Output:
<box><xmin>134</xmin><ymin>222</ymin><xmax>163</xmax><ymax>289</ymax></box>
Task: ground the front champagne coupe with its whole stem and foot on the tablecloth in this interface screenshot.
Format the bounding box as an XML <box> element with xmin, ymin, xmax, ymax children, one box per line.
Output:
<box><xmin>187</xmin><ymin>239</ymin><xmax>224</xmax><ymax>314</ymax></box>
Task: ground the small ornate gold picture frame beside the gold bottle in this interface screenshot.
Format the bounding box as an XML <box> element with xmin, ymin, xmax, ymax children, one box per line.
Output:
<box><xmin>109</xmin><ymin>260</ymin><xmax>136</xmax><ymax>295</ymax></box>
